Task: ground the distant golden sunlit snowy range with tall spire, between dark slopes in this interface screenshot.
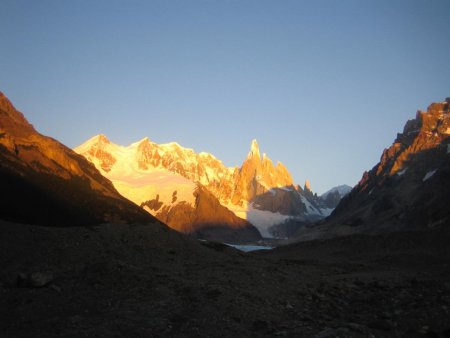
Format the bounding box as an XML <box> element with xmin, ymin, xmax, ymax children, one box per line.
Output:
<box><xmin>74</xmin><ymin>134</ymin><xmax>345</xmax><ymax>242</ymax></box>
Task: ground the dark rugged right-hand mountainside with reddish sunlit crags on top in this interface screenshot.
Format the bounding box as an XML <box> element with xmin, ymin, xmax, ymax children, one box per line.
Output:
<box><xmin>331</xmin><ymin>98</ymin><xmax>450</xmax><ymax>229</ymax></box>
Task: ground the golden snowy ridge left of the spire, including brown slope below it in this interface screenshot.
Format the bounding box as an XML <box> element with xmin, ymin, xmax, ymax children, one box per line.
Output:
<box><xmin>75</xmin><ymin>135</ymin><xmax>261</xmax><ymax>243</ymax></box>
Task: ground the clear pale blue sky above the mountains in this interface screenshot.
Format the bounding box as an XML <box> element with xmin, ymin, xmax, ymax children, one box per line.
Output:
<box><xmin>0</xmin><ymin>0</ymin><xmax>450</xmax><ymax>193</ymax></box>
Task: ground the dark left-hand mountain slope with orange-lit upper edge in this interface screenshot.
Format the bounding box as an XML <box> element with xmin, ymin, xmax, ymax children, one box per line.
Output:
<box><xmin>0</xmin><ymin>93</ymin><xmax>154</xmax><ymax>225</ymax></box>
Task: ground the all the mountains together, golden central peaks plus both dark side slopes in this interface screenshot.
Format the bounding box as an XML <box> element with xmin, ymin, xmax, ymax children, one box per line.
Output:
<box><xmin>0</xmin><ymin>93</ymin><xmax>450</xmax><ymax>243</ymax></box>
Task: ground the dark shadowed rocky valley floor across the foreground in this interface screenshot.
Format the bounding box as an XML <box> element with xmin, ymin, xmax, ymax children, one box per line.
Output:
<box><xmin>0</xmin><ymin>222</ymin><xmax>450</xmax><ymax>338</ymax></box>
